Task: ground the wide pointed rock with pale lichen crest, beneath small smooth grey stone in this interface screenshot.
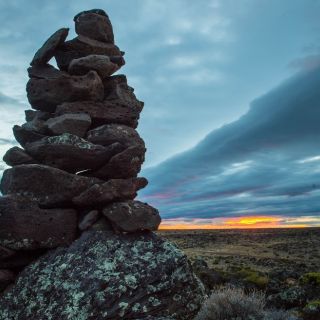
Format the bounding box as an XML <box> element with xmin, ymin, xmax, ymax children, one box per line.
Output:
<box><xmin>25</xmin><ymin>133</ymin><xmax>124</xmax><ymax>173</ymax></box>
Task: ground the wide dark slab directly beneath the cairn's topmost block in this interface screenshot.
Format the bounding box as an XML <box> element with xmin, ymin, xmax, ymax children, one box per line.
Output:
<box><xmin>55</xmin><ymin>36</ymin><xmax>125</xmax><ymax>71</ymax></box>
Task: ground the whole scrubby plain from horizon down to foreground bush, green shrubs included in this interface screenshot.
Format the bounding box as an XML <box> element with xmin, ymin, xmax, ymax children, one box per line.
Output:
<box><xmin>159</xmin><ymin>228</ymin><xmax>320</xmax><ymax>319</ymax></box>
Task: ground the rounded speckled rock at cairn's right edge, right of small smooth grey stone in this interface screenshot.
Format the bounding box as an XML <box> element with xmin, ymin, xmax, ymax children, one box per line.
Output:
<box><xmin>87</xmin><ymin>123</ymin><xmax>145</xmax><ymax>147</ymax></box>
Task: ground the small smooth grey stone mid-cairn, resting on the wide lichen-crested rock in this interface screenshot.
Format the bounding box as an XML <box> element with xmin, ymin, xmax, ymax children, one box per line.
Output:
<box><xmin>45</xmin><ymin>113</ymin><xmax>91</xmax><ymax>138</ymax></box>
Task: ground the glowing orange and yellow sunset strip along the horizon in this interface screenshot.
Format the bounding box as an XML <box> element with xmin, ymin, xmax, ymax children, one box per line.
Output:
<box><xmin>160</xmin><ymin>216</ymin><xmax>320</xmax><ymax>230</ymax></box>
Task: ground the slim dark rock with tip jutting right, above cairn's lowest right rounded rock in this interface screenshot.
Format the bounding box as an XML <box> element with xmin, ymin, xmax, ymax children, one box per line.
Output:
<box><xmin>72</xmin><ymin>178</ymin><xmax>148</xmax><ymax>206</ymax></box>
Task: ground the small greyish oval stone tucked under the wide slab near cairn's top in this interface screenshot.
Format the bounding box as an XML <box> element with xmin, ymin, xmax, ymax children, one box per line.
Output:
<box><xmin>68</xmin><ymin>54</ymin><xmax>119</xmax><ymax>79</ymax></box>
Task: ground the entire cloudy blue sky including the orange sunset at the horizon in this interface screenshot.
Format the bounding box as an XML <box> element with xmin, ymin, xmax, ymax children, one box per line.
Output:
<box><xmin>0</xmin><ymin>0</ymin><xmax>320</xmax><ymax>228</ymax></box>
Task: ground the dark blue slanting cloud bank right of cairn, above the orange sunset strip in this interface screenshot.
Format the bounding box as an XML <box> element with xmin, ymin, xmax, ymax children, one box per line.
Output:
<box><xmin>140</xmin><ymin>67</ymin><xmax>320</xmax><ymax>219</ymax></box>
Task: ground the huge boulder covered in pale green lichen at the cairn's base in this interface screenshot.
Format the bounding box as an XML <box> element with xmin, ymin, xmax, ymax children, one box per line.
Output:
<box><xmin>0</xmin><ymin>231</ymin><xmax>204</xmax><ymax>320</ymax></box>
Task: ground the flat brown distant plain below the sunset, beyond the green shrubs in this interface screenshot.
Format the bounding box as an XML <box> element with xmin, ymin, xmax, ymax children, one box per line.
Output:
<box><xmin>159</xmin><ymin>228</ymin><xmax>320</xmax><ymax>273</ymax></box>
